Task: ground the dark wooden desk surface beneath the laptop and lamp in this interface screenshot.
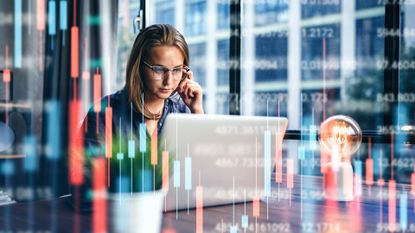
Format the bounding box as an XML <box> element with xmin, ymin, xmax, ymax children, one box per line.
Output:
<box><xmin>0</xmin><ymin>177</ymin><xmax>415</xmax><ymax>233</ymax></box>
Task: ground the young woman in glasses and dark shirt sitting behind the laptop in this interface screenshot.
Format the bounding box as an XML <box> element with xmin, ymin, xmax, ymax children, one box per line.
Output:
<box><xmin>74</xmin><ymin>24</ymin><xmax>204</xmax><ymax>210</ymax></box>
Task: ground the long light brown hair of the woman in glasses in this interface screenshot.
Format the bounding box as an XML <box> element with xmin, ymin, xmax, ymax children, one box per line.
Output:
<box><xmin>124</xmin><ymin>24</ymin><xmax>189</xmax><ymax>119</ymax></box>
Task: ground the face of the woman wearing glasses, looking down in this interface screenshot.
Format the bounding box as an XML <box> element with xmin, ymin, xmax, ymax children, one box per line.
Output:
<box><xmin>143</xmin><ymin>46</ymin><xmax>184</xmax><ymax>100</ymax></box>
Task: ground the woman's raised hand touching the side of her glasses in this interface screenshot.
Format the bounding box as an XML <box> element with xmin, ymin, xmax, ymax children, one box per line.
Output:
<box><xmin>177</xmin><ymin>70</ymin><xmax>204</xmax><ymax>114</ymax></box>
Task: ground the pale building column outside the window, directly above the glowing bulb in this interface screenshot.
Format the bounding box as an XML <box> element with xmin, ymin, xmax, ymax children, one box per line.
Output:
<box><xmin>340</xmin><ymin>0</ymin><xmax>356</xmax><ymax>101</ymax></box>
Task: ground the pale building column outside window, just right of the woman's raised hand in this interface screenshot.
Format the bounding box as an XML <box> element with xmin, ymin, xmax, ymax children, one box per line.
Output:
<box><xmin>205</xmin><ymin>0</ymin><xmax>217</xmax><ymax>114</ymax></box>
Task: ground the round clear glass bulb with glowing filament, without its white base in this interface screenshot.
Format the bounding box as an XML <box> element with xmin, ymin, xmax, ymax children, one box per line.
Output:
<box><xmin>318</xmin><ymin>115</ymin><xmax>362</xmax><ymax>158</ymax></box>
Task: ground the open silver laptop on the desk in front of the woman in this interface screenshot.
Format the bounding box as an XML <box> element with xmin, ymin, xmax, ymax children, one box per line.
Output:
<box><xmin>159</xmin><ymin>114</ymin><xmax>288</xmax><ymax>211</ymax></box>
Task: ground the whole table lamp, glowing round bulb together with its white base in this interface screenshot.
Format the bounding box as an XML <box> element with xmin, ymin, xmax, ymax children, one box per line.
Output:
<box><xmin>318</xmin><ymin>115</ymin><xmax>362</xmax><ymax>201</ymax></box>
